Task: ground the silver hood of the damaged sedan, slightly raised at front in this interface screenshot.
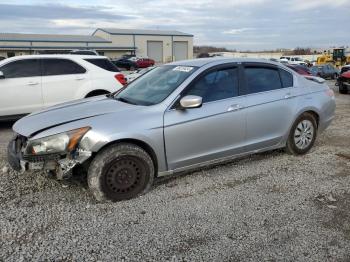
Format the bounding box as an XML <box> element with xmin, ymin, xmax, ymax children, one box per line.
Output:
<box><xmin>13</xmin><ymin>96</ymin><xmax>138</xmax><ymax>137</ymax></box>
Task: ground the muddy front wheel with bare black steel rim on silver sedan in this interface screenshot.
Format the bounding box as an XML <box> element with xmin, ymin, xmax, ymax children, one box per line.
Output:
<box><xmin>88</xmin><ymin>143</ymin><xmax>154</xmax><ymax>201</ymax></box>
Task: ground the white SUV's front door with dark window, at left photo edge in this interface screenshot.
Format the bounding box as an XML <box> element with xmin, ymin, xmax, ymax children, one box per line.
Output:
<box><xmin>0</xmin><ymin>59</ymin><xmax>43</xmax><ymax>116</ymax></box>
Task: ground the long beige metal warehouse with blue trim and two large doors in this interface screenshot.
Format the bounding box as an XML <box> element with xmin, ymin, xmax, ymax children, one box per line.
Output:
<box><xmin>0</xmin><ymin>28</ymin><xmax>193</xmax><ymax>62</ymax></box>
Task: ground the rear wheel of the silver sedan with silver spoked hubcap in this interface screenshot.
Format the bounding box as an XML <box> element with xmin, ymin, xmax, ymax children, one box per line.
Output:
<box><xmin>286</xmin><ymin>113</ymin><xmax>317</xmax><ymax>155</ymax></box>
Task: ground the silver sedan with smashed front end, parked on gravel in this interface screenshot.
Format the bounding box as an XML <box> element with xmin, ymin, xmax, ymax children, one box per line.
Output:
<box><xmin>8</xmin><ymin>58</ymin><xmax>335</xmax><ymax>201</ymax></box>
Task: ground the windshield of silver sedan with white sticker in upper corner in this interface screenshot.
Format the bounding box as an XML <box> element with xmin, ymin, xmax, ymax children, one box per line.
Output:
<box><xmin>115</xmin><ymin>65</ymin><xmax>197</xmax><ymax>106</ymax></box>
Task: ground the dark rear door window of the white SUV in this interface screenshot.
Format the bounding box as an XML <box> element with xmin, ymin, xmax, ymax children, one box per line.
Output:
<box><xmin>42</xmin><ymin>58</ymin><xmax>86</xmax><ymax>76</ymax></box>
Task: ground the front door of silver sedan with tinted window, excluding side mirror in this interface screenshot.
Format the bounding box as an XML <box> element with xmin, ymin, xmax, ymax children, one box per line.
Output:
<box><xmin>164</xmin><ymin>66</ymin><xmax>246</xmax><ymax>170</ymax></box>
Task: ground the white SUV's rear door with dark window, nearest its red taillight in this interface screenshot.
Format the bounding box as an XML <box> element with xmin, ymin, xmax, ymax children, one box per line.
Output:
<box><xmin>41</xmin><ymin>58</ymin><xmax>91</xmax><ymax>107</ymax></box>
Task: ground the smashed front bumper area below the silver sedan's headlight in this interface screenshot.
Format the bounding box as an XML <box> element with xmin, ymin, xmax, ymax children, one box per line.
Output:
<box><xmin>7</xmin><ymin>135</ymin><xmax>92</xmax><ymax>179</ymax></box>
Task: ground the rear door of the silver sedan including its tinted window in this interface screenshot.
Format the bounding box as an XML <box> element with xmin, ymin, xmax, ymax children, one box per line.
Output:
<box><xmin>243</xmin><ymin>63</ymin><xmax>297</xmax><ymax>151</ymax></box>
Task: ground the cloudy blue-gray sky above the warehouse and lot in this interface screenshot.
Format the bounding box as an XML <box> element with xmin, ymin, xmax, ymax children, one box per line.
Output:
<box><xmin>0</xmin><ymin>0</ymin><xmax>350</xmax><ymax>50</ymax></box>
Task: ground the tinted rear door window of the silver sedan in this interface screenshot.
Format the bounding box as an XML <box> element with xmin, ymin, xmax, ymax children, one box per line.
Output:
<box><xmin>244</xmin><ymin>67</ymin><xmax>282</xmax><ymax>94</ymax></box>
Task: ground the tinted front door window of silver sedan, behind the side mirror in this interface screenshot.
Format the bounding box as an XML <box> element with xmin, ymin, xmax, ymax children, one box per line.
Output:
<box><xmin>184</xmin><ymin>68</ymin><xmax>238</xmax><ymax>103</ymax></box>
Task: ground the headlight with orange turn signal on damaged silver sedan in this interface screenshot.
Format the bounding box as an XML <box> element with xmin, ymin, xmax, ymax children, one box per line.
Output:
<box><xmin>25</xmin><ymin>127</ymin><xmax>90</xmax><ymax>155</ymax></box>
